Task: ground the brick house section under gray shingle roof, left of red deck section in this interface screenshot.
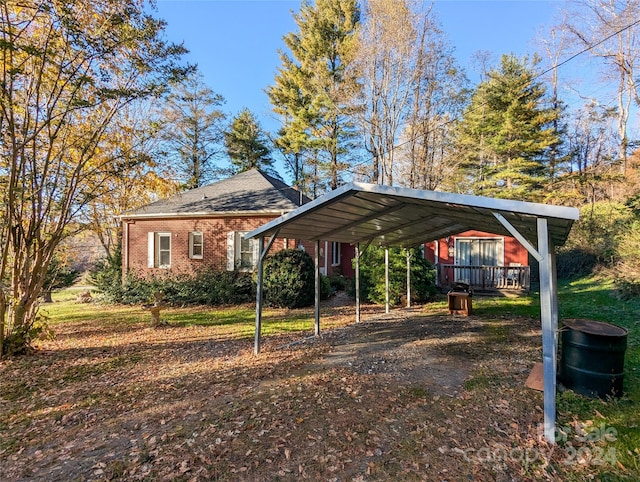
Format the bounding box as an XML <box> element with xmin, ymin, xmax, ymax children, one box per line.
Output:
<box><xmin>121</xmin><ymin>169</ymin><xmax>351</xmax><ymax>276</ymax></box>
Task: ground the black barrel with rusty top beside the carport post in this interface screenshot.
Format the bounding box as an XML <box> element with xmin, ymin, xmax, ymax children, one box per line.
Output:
<box><xmin>560</xmin><ymin>318</ymin><xmax>628</xmax><ymax>398</ymax></box>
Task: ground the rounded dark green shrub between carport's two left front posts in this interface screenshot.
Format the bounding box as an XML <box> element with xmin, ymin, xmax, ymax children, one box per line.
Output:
<box><xmin>263</xmin><ymin>249</ymin><xmax>315</xmax><ymax>308</ymax></box>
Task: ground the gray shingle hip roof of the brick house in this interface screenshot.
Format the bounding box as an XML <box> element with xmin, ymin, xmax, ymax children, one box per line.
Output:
<box><xmin>122</xmin><ymin>169</ymin><xmax>307</xmax><ymax>218</ymax></box>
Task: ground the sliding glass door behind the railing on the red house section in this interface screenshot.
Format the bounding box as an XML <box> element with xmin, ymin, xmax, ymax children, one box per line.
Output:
<box><xmin>454</xmin><ymin>238</ymin><xmax>504</xmax><ymax>286</ymax></box>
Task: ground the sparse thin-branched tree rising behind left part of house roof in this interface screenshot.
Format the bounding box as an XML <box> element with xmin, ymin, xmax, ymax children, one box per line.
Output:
<box><xmin>161</xmin><ymin>72</ymin><xmax>225</xmax><ymax>189</ymax></box>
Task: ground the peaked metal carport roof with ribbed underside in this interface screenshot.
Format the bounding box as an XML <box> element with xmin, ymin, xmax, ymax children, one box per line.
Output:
<box><xmin>246</xmin><ymin>182</ymin><xmax>578</xmax><ymax>247</ymax></box>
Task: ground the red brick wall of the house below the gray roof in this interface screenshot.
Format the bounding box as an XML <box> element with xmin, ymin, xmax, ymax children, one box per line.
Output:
<box><xmin>123</xmin><ymin>216</ymin><xmax>295</xmax><ymax>276</ymax></box>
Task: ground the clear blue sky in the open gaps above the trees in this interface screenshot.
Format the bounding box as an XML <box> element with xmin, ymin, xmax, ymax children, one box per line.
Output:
<box><xmin>157</xmin><ymin>0</ymin><xmax>562</xmax><ymax>178</ymax></box>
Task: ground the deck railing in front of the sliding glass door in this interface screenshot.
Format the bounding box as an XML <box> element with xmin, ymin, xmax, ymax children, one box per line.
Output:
<box><xmin>438</xmin><ymin>264</ymin><xmax>531</xmax><ymax>290</ymax></box>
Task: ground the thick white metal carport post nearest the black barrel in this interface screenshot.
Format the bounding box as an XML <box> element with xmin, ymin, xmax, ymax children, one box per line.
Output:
<box><xmin>538</xmin><ymin>218</ymin><xmax>558</xmax><ymax>444</ymax></box>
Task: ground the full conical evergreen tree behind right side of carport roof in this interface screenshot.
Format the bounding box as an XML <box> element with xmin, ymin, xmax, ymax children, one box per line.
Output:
<box><xmin>457</xmin><ymin>55</ymin><xmax>559</xmax><ymax>201</ymax></box>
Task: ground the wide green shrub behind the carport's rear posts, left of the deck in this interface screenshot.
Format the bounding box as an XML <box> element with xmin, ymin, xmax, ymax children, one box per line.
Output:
<box><xmin>351</xmin><ymin>246</ymin><xmax>437</xmax><ymax>305</ymax></box>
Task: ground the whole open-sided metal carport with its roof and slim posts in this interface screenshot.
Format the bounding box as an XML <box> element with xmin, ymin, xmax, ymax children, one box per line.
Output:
<box><xmin>246</xmin><ymin>183</ymin><xmax>579</xmax><ymax>443</ymax></box>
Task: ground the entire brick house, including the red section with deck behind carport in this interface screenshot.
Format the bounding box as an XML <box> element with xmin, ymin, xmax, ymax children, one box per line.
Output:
<box><xmin>121</xmin><ymin>169</ymin><xmax>529</xmax><ymax>288</ymax></box>
